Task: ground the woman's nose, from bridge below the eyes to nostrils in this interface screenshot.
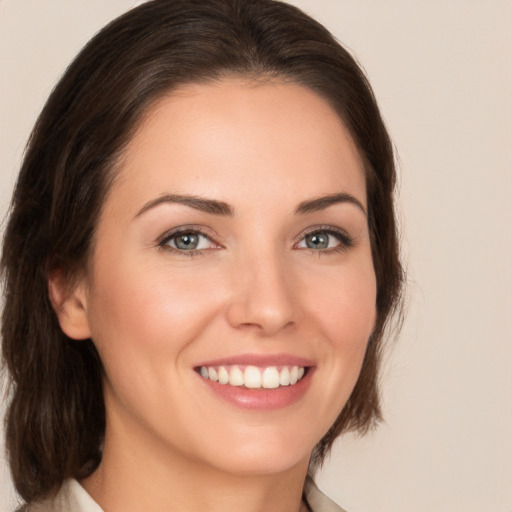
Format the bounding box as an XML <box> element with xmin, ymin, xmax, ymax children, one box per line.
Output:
<box><xmin>227</xmin><ymin>251</ymin><xmax>297</xmax><ymax>336</ymax></box>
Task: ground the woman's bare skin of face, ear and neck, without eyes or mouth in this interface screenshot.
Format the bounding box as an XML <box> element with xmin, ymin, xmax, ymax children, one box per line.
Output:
<box><xmin>50</xmin><ymin>79</ymin><xmax>376</xmax><ymax>512</ymax></box>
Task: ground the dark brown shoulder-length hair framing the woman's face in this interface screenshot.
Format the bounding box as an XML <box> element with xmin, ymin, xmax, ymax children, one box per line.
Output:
<box><xmin>1</xmin><ymin>0</ymin><xmax>403</xmax><ymax>502</ymax></box>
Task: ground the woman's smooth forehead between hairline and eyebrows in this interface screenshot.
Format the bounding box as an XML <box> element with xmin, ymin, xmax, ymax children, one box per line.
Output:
<box><xmin>110</xmin><ymin>79</ymin><xmax>366</xmax><ymax>212</ymax></box>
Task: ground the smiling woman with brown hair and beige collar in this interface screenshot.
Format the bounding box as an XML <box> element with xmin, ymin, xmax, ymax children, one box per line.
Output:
<box><xmin>2</xmin><ymin>0</ymin><xmax>402</xmax><ymax>512</ymax></box>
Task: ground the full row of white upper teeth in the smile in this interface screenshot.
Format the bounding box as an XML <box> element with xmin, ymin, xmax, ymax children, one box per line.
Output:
<box><xmin>199</xmin><ymin>365</ymin><xmax>305</xmax><ymax>389</ymax></box>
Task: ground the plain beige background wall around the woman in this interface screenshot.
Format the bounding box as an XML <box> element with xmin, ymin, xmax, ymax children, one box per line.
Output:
<box><xmin>0</xmin><ymin>0</ymin><xmax>512</xmax><ymax>512</ymax></box>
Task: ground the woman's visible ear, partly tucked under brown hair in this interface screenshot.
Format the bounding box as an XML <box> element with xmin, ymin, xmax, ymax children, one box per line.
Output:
<box><xmin>48</xmin><ymin>269</ymin><xmax>91</xmax><ymax>340</ymax></box>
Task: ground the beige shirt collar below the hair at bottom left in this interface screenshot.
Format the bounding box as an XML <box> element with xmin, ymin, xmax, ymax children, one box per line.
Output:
<box><xmin>21</xmin><ymin>479</ymin><xmax>103</xmax><ymax>512</ymax></box>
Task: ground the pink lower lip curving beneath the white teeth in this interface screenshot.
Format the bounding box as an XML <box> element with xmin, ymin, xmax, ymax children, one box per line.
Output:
<box><xmin>198</xmin><ymin>368</ymin><xmax>314</xmax><ymax>411</ymax></box>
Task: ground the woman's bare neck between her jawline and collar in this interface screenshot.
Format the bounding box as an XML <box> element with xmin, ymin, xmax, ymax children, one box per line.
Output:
<box><xmin>81</xmin><ymin>406</ymin><xmax>309</xmax><ymax>512</ymax></box>
